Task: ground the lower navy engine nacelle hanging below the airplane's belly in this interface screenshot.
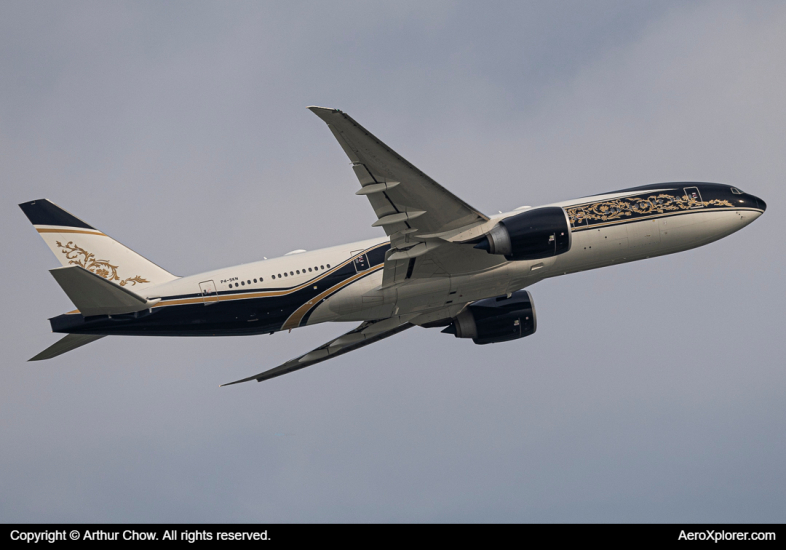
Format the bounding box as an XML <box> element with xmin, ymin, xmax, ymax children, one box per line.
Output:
<box><xmin>442</xmin><ymin>290</ymin><xmax>538</xmax><ymax>344</ymax></box>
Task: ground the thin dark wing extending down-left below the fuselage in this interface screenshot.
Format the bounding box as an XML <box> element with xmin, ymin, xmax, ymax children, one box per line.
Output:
<box><xmin>214</xmin><ymin>316</ymin><xmax>414</xmax><ymax>386</ymax></box>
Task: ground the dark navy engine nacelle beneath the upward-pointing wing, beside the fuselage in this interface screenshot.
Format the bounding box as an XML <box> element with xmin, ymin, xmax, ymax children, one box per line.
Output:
<box><xmin>475</xmin><ymin>206</ymin><xmax>570</xmax><ymax>261</ymax></box>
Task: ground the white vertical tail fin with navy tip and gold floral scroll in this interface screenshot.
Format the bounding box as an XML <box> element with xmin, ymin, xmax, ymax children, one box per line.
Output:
<box><xmin>19</xmin><ymin>199</ymin><xmax>177</xmax><ymax>292</ymax></box>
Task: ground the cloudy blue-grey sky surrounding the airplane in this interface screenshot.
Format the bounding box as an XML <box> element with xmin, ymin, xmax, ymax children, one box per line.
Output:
<box><xmin>0</xmin><ymin>1</ymin><xmax>786</xmax><ymax>522</ymax></box>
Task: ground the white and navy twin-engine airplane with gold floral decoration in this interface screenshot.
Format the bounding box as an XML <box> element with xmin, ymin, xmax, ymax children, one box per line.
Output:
<box><xmin>19</xmin><ymin>107</ymin><xmax>767</xmax><ymax>385</ymax></box>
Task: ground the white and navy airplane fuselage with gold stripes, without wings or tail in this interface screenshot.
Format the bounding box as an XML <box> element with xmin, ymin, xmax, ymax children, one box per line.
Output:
<box><xmin>50</xmin><ymin>183</ymin><xmax>766</xmax><ymax>336</ymax></box>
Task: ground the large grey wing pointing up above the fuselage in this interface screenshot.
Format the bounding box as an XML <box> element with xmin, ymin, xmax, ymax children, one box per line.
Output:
<box><xmin>309</xmin><ymin>107</ymin><xmax>488</xmax><ymax>240</ymax></box>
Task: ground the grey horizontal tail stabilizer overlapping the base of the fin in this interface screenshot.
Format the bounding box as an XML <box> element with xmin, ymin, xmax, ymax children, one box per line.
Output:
<box><xmin>49</xmin><ymin>265</ymin><xmax>160</xmax><ymax>317</ymax></box>
